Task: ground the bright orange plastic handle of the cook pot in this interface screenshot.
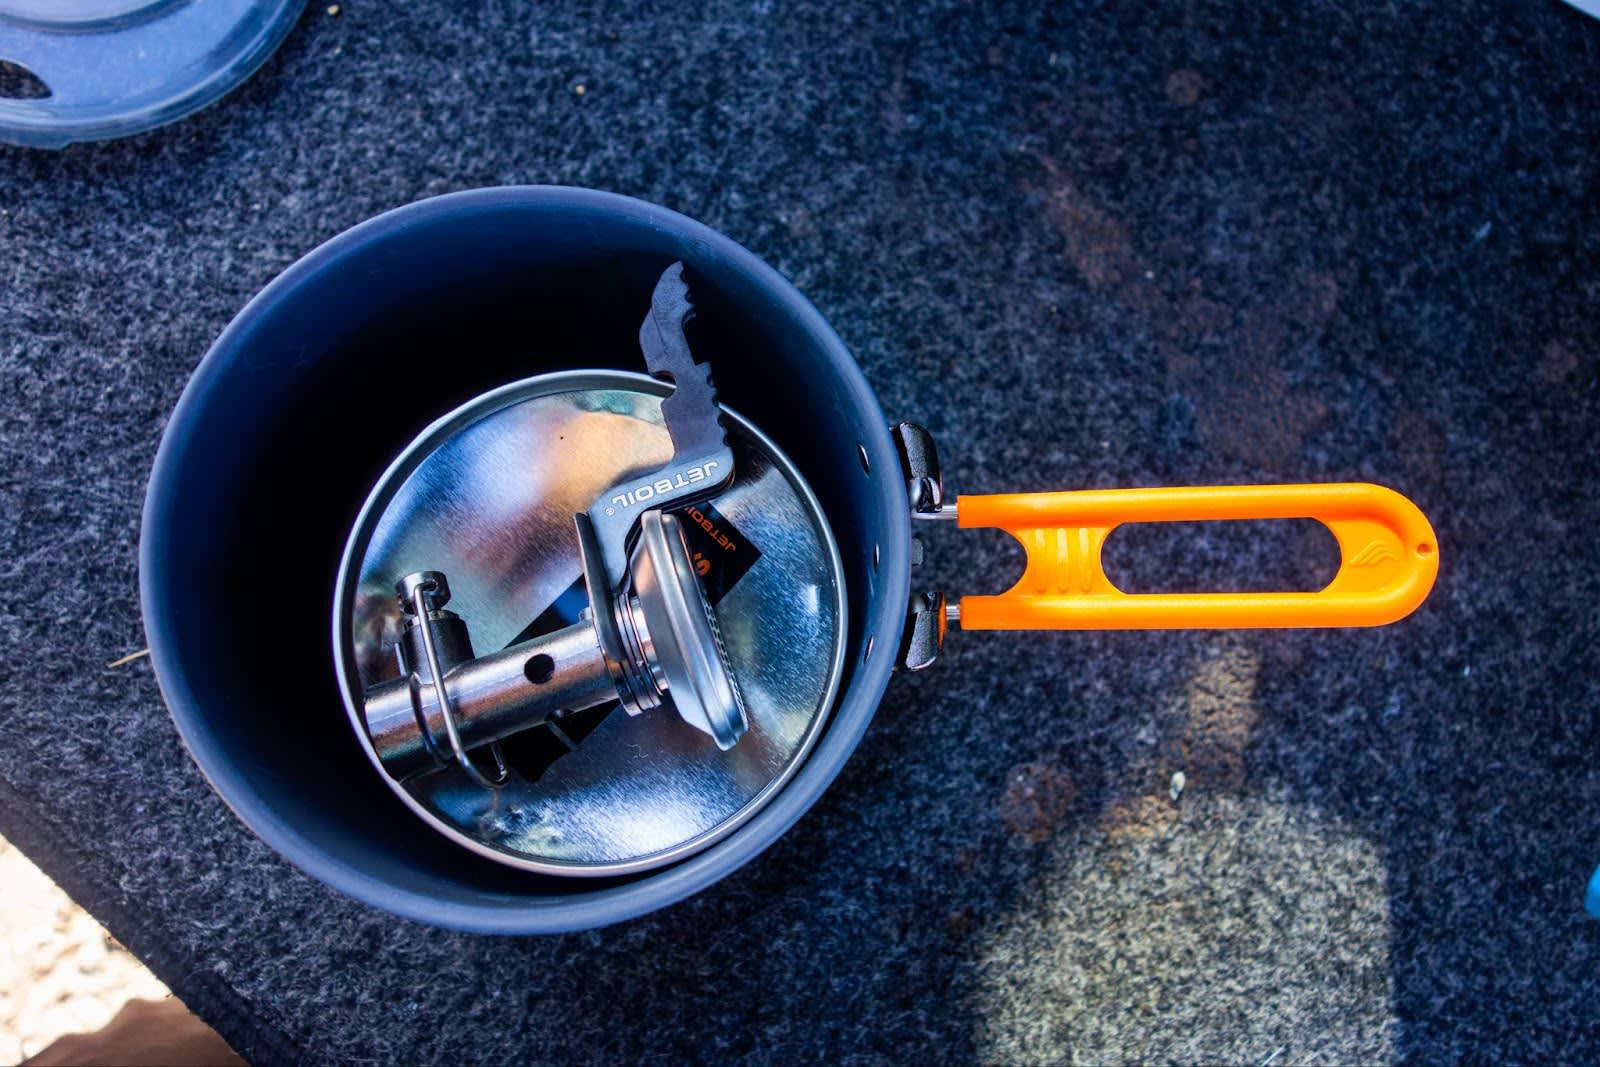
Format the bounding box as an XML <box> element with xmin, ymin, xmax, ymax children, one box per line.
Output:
<box><xmin>955</xmin><ymin>483</ymin><xmax>1438</xmax><ymax>630</ymax></box>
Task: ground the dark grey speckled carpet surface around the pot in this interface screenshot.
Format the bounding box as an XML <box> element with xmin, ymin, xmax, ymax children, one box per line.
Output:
<box><xmin>0</xmin><ymin>0</ymin><xmax>1600</xmax><ymax>1064</ymax></box>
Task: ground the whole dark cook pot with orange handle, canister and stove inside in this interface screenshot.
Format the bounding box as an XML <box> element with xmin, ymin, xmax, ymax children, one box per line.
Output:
<box><xmin>141</xmin><ymin>187</ymin><xmax>1438</xmax><ymax>933</ymax></box>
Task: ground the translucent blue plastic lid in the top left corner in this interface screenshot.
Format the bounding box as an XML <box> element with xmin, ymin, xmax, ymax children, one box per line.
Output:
<box><xmin>0</xmin><ymin>0</ymin><xmax>306</xmax><ymax>149</ymax></box>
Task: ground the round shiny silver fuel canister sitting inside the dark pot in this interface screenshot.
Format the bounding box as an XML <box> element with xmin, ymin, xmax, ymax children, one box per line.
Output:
<box><xmin>334</xmin><ymin>371</ymin><xmax>845</xmax><ymax>877</ymax></box>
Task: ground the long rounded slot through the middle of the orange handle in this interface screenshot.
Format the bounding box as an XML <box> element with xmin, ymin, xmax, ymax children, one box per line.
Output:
<box><xmin>1101</xmin><ymin>518</ymin><xmax>1339</xmax><ymax>593</ymax></box>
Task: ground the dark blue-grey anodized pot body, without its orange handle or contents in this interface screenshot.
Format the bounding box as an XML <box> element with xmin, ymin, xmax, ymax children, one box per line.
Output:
<box><xmin>141</xmin><ymin>187</ymin><xmax>910</xmax><ymax>933</ymax></box>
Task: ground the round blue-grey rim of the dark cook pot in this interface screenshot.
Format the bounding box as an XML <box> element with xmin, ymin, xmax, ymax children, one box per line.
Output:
<box><xmin>139</xmin><ymin>186</ymin><xmax>910</xmax><ymax>934</ymax></box>
